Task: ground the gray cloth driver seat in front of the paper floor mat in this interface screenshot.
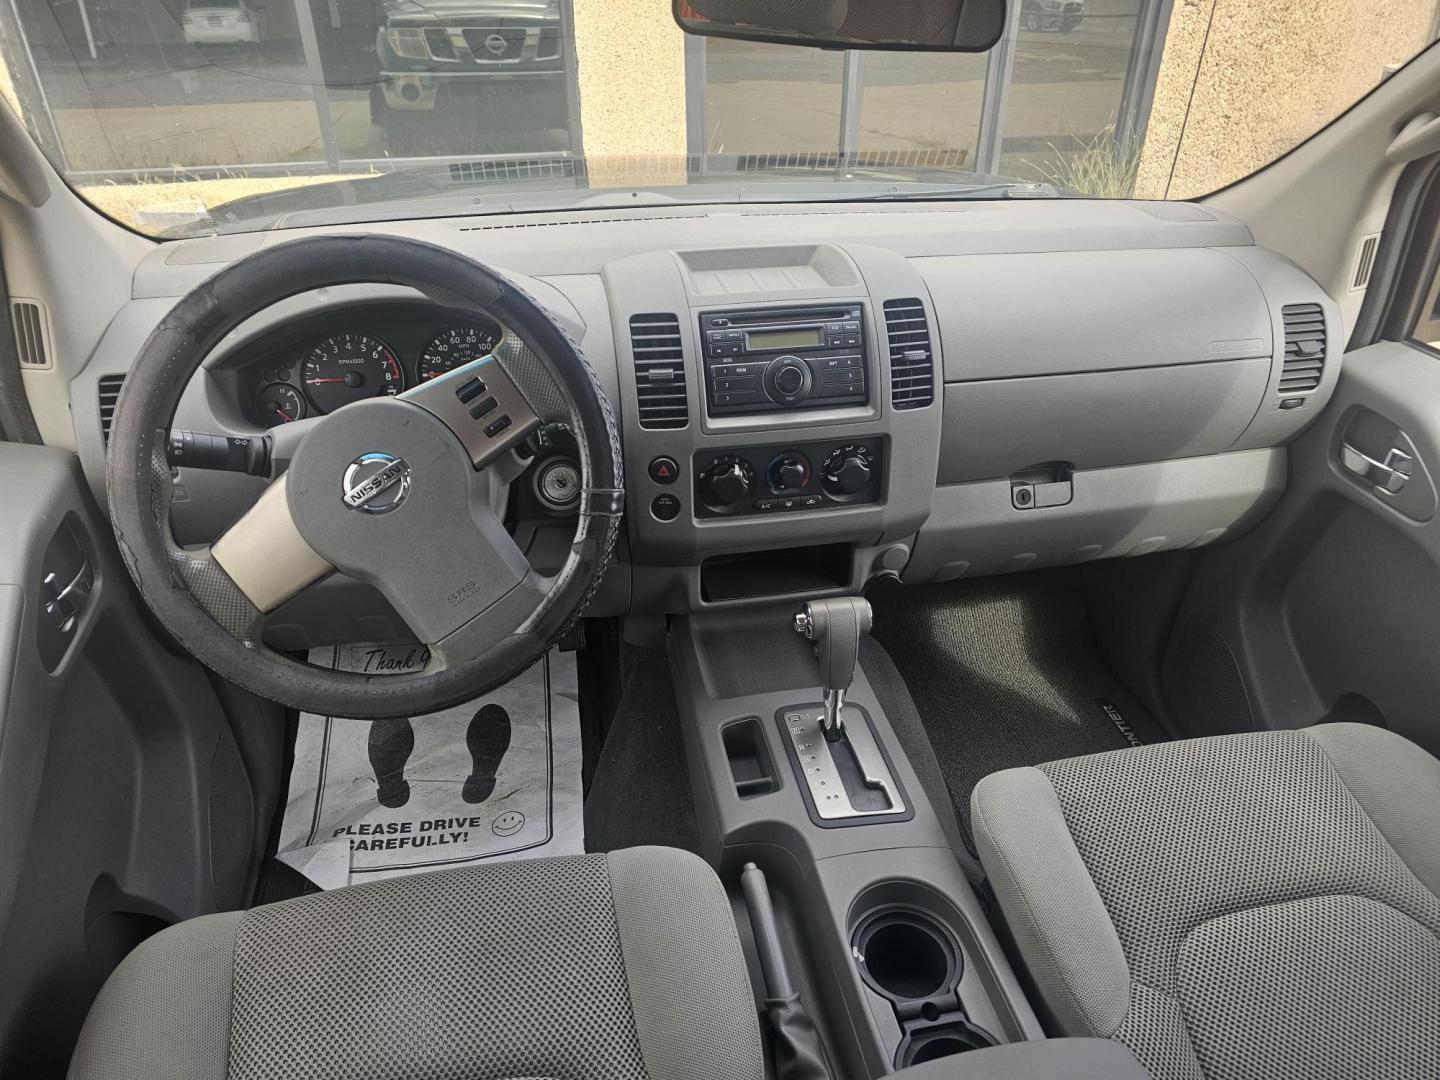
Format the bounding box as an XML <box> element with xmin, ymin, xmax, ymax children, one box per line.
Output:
<box><xmin>69</xmin><ymin>848</ymin><xmax>765</xmax><ymax>1080</ymax></box>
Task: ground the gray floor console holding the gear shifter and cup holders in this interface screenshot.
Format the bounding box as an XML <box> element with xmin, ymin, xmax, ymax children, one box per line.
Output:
<box><xmin>667</xmin><ymin>596</ymin><xmax>1064</xmax><ymax>1077</ymax></box>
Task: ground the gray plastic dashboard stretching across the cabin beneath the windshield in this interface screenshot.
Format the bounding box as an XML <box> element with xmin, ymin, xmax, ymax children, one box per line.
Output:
<box><xmin>71</xmin><ymin>200</ymin><xmax>1344</xmax><ymax>644</ymax></box>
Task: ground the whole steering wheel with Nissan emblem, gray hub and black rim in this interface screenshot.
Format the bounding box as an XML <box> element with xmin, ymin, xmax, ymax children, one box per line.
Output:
<box><xmin>108</xmin><ymin>236</ymin><xmax>624</xmax><ymax>719</ymax></box>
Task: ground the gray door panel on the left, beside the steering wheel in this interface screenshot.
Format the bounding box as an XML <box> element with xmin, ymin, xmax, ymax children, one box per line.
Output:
<box><xmin>0</xmin><ymin>444</ymin><xmax>255</xmax><ymax>1077</ymax></box>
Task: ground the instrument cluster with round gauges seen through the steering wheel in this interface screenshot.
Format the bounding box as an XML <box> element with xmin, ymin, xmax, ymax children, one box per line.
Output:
<box><xmin>245</xmin><ymin>314</ymin><xmax>504</xmax><ymax>428</ymax></box>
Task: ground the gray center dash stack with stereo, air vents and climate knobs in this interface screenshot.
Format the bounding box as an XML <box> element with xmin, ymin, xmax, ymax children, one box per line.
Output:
<box><xmin>603</xmin><ymin>243</ymin><xmax>940</xmax><ymax>601</ymax></box>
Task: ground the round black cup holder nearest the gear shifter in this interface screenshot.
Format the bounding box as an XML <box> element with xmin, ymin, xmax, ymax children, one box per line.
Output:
<box><xmin>852</xmin><ymin>909</ymin><xmax>963</xmax><ymax>1002</ymax></box>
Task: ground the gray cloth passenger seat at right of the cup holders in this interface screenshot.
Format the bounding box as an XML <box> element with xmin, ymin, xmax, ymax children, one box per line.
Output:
<box><xmin>972</xmin><ymin>724</ymin><xmax>1440</xmax><ymax>1080</ymax></box>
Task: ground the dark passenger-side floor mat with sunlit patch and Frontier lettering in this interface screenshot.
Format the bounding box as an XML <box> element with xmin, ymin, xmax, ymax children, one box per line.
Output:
<box><xmin>870</xmin><ymin>570</ymin><xmax>1156</xmax><ymax>848</ymax></box>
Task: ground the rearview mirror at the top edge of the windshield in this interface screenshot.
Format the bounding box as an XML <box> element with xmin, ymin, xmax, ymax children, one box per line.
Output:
<box><xmin>672</xmin><ymin>0</ymin><xmax>1007</xmax><ymax>52</ymax></box>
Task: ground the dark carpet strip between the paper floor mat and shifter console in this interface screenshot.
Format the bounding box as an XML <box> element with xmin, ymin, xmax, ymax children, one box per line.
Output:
<box><xmin>585</xmin><ymin>645</ymin><xmax>700</xmax><ymax>854</ymax></box>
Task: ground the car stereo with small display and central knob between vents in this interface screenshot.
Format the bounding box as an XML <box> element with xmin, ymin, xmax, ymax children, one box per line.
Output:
<box><xmin>700</xmin><ymin>304</ymin><xmax>868</xmax><ymax>416</ymax></box>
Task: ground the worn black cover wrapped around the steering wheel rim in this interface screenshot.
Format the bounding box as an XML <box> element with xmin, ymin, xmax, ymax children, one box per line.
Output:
<box><xmin>108</xmin><ymin>235</ymin><xmax>624</xmax><ymax>719</ymax></box>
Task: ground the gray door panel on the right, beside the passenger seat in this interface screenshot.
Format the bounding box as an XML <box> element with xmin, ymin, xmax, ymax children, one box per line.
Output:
<box><xmin>1165</xmin><ymin>341</ymin><xmax>1440</xmax><ymax>755</ymax></box>
